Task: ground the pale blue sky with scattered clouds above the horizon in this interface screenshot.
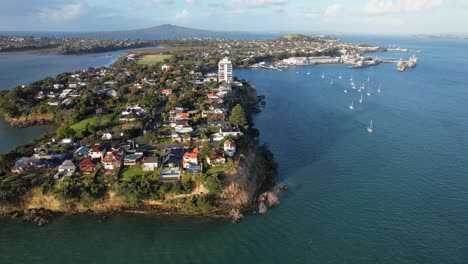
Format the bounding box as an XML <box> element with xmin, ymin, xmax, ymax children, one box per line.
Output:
<box><xmin>0</xmin><ymin>0</ymin><xmax>468</xmax><ymax>34</ymax></box>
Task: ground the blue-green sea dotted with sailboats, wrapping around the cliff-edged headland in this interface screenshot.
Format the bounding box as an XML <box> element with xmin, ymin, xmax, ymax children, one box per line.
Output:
<box><xmin>0</xmin><ymin>38</ymin><xmax>468</xmax><ymax>264</ymax></box>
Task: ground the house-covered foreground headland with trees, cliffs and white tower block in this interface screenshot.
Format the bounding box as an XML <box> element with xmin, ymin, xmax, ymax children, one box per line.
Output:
<box><xmin>0</xmin><ymin>51</ymin><xmax>277</xmax><ymax>225</ymax></box>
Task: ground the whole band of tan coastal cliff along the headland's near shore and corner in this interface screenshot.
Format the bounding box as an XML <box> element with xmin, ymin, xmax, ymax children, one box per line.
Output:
<box><xmin>0</xmin><ymin>142</ymin><xmax>277</xmax><ymax>222</ymax></box>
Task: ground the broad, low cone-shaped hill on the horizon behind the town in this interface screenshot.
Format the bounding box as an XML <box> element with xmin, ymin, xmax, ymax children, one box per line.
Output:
<box><xmin>89</xmin><ymin>24</ymin><xmax>247</xmax><ymax>37</ymax></box>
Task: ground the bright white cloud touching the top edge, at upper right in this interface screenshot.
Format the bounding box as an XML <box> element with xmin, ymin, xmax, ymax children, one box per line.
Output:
<box><xmin>364</xmin><ymin>0</ymin><xmax>444</xmax><ymax>15</ymax></box>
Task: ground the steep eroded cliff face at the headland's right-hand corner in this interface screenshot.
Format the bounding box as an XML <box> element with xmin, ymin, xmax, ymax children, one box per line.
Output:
<box><xmin>220</xmin><ymin>144</ymin><xmax>277</xmax><ymax>209</ymax></box>
